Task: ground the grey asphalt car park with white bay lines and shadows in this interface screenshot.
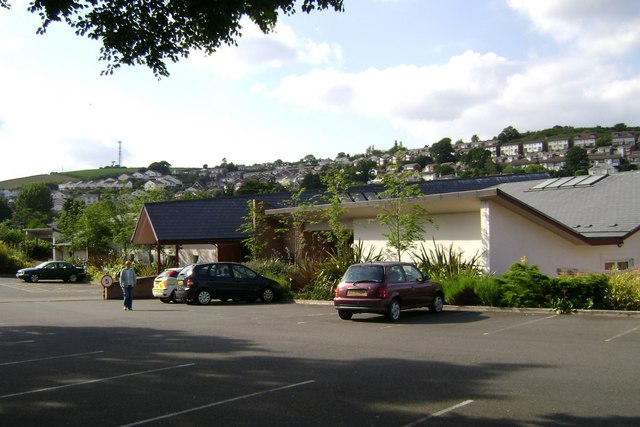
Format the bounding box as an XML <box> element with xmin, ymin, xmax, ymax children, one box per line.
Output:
<box><xmin>0</xmin><ymin>278</ymin><xmax>640</xmax><ymax>427</ymax></box>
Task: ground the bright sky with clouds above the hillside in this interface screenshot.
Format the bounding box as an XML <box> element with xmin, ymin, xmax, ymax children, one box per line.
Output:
<box><xmin>0</xmin><ymin>0</ymin><xmax>640</xmax><ymax>180</ymax></box>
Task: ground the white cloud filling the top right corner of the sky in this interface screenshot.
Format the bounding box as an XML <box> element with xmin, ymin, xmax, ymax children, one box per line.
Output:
<box><xmin>508</xmin><ymin>0</ymin><xmax>640</xmax><ymax>55</ymax></box>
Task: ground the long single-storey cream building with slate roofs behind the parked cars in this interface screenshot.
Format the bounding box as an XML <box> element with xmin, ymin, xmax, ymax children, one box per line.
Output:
<box><xmin>132</xmin><ymin>172</ymin><xmax>640</xmax><ymax>275</ymax></box>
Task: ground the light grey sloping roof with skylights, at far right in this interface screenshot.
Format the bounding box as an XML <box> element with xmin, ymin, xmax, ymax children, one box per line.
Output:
<box><xmin>498</xmin><ymin>171</ymin><xmax>640</xmax><ymax>239</ymax></box>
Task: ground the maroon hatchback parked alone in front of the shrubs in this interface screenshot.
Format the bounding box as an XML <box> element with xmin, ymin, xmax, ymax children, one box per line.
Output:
<box><xmin>333</xmin><ymin>262</ymin><xmax>444</xmax><ymax>321</ymax></box>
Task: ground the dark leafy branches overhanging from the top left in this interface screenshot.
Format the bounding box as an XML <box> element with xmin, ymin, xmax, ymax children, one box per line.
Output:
<box><xmin>0</xmin><ymin>0</ymin><xmax>343</xmax><ymax>77</ymax></box>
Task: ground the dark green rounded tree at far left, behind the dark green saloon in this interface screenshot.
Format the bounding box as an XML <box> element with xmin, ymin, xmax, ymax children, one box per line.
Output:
<box><xmin>14</xmin><ymin>183</ymin><xmax>53</xmax><ymax>228</ymax></box>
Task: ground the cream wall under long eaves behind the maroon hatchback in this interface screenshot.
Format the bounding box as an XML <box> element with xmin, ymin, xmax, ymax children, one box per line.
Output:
<box><xmin>353</xmin><ymin>212</ymin><xmax>483</xmax><ymax>261</ymax></box>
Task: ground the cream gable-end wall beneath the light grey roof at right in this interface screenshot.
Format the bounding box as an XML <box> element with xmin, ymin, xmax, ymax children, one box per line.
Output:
<box><xmin>481</xmin><ymin>201</ymin><xmax>640</xmax><ymax>276</ymax></box>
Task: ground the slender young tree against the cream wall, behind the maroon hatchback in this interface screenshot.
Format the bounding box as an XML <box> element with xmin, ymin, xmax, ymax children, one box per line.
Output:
<box><xmin>376</xmin><ymin>175</ymin><xmax>433</xmax><ymax>261</ymax></box>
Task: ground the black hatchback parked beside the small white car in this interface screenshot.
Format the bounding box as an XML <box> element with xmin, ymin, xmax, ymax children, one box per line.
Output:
<box><xmin>176</xmin><ymin>262</ymin><xmax>281</xmax><ymax>305</ymax></box>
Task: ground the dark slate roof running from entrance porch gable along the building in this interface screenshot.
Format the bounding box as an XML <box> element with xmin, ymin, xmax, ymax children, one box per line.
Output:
<box><xmin>132</xmin><ymin>173</ymin><xmax>549</xmax><ymax>245</ymax></box>
